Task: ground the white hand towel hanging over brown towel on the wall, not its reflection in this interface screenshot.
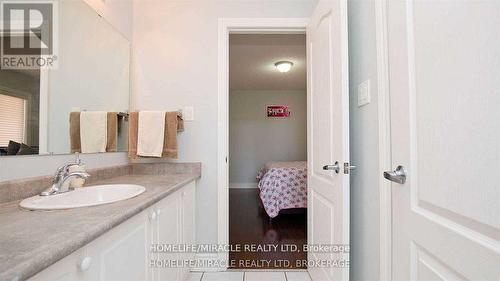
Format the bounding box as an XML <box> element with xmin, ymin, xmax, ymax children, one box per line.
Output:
<box><xmin>137</xmin><ymin>111</ymin><xmax>165</xmax><ymax>157</ymax></box>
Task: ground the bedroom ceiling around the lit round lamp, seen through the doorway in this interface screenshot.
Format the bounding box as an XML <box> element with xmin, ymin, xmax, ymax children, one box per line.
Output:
<box><xmin>229</xmin><ymin>34</ymin><xmax>307</xmax><ymax>90</ymax></box>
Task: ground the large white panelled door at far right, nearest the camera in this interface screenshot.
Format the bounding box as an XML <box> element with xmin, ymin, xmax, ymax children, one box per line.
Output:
<box><xmin>387</xmin><ymin>0</ymin><xmax>500</xmax><ymax>280</ymax></box>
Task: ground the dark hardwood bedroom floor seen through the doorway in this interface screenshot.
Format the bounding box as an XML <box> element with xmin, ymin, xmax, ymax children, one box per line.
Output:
<box><xmin>229</xmin><ymin>188</ymin><xmax>307</xmax><ymax>269</ymax></box>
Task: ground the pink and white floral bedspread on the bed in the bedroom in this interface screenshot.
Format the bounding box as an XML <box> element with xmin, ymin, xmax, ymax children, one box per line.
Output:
<box><xmin>257</xmin><ymin>161</ymin><xmax>307</xmax><ymax>218</ymax></box>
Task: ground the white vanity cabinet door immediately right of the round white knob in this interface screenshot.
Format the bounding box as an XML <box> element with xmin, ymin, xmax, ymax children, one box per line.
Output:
<box><xmin>85</xmin><ymin>212</ymin><xmax>151</xmax><ymax>281</ymax></box>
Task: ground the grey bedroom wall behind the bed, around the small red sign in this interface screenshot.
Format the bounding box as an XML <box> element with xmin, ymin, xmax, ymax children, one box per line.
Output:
<box><xmin>229</xmin><ymin>91</ymin><xmax>307</xmax><ymax>185</ymax></box>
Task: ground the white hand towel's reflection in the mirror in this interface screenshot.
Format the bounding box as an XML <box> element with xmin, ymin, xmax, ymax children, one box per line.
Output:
<box><xmin>80</xmin><ymin>111</ymin><xmax>108</xmax><ymax>153</ymax></box>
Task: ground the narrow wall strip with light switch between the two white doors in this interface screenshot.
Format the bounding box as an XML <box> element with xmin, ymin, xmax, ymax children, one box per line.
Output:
<box><xmin>348</xmin><ymin>0</ymin><xmax>380</xmax><ymax>280</ymax></box>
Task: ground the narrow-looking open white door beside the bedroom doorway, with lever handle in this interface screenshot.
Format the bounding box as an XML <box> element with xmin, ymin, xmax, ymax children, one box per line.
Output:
<box><xmin>307</xmin><ymin>0</ymin><xmax>349</xmax><ymax>280</ymax></box>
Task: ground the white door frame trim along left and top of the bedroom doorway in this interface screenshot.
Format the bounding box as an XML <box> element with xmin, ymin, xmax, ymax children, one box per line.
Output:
<box><xmin>218</xmin><ymin>18</ymin><xmax>309</xmax><ymax>270</ymax></box>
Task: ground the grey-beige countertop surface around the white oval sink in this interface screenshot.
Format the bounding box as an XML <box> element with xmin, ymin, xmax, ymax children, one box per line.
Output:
<box><xmin>0</xmin><ymin>173</ymin><xmax>200</xmax><ymax>280</ymax></box>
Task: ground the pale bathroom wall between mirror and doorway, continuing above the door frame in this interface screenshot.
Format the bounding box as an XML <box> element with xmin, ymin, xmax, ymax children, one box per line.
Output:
<box><xmin>132</xmin><ymin>0</ymin><xmax>315</xmax><ymax>243</ymax></box>
